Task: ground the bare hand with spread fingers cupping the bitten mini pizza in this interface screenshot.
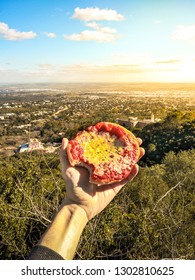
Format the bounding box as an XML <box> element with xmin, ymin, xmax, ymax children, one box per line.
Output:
<box><xmin>60</xmin><ymin>138</ymin><xmax>145</xmax><ymax>220</ymax></box>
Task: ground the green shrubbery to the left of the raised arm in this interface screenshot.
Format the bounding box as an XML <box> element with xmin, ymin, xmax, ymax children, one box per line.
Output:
<box><xmin>0</xmin><ymin>153</ymin><xmax>64</xmax><ymax>259</ymax></box>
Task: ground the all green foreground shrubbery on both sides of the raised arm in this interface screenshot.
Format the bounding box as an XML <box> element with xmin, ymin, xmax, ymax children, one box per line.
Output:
<box><xmin>0</xmin><ymin>150</ymin><xmax>195</xmax><ymax>259</ymax></box>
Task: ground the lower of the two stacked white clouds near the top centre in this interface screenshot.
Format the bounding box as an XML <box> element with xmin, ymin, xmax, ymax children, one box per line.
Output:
<box><xmin>64</xmin><ymin>22</ymin><xmax>120</xmax><ymax>43</ymax></box>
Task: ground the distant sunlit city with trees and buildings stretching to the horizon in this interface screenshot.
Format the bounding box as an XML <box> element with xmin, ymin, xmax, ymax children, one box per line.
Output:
<box><xmin>0</xmin><ymin>83</ymin><xmax>195</xmax><ymax>158</ymax></box>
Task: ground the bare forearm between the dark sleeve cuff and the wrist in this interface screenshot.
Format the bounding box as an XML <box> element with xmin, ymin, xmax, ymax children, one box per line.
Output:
<box><xmin>39</xmin><ymin>204</ymin><xmax>88</xmax><ymax>260</ymax></box>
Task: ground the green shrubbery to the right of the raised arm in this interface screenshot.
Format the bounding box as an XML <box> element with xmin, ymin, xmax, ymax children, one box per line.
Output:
<box><xmin>77</xmin><ymin>150</ymin><xmax>195</xmax><ymax>259</ymax></box>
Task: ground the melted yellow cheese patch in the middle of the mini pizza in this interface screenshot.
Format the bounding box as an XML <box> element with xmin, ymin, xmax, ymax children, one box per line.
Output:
<box><xmin>81</xmin><ymin>132</ymin><xmax>123</xmax><ymax>164</ymax></box>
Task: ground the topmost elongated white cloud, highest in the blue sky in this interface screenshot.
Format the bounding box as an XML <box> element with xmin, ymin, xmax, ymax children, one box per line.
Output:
<box><xmin>72</xmin><ymin>8</ymin><xmax>124</xmax><ymax>21</ymax></box>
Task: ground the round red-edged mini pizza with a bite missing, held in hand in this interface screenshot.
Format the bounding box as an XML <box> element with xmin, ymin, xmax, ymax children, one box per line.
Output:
<box><xmin>67</xmin><ymin>122</ymin><xmax>140</xmax><ymax>185</ymax></box>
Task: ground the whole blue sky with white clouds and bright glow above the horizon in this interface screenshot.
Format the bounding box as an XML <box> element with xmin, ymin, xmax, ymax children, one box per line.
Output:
<box><xmin>0</xmin><ymin>0</ymin><xmax>195</xmax><ymax>83</ymax></box>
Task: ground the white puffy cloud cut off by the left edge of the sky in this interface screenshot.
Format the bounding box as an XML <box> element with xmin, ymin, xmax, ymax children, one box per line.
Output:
<box><xmin>0</xmin><ymin>22</ymin><xmax>37</xmax><ymax>41</ymax></box>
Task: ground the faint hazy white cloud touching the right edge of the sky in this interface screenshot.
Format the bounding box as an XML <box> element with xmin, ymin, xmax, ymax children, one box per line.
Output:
<box><xmin>172</xmin><ymin>25</ymin><xmax>195</xmax><ymax>41</ymax></box>
